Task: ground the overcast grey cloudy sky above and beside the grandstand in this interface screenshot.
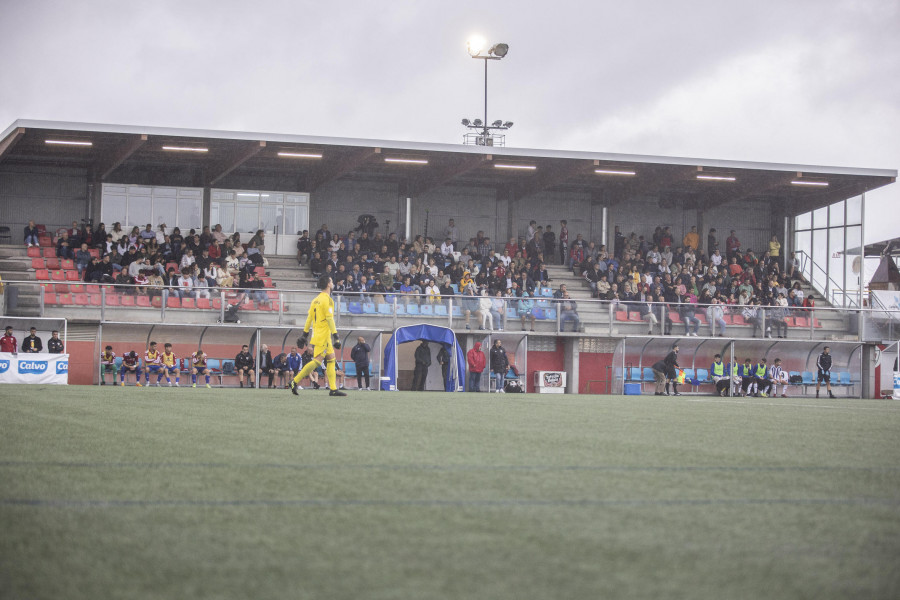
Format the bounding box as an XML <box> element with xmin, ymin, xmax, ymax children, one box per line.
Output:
<box><xmin>0</xmin><ymin>0</ymin><xmax>900</xmax><ymax>241</ymax></box>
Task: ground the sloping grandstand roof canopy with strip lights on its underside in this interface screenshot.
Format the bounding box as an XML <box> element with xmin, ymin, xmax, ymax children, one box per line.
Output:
<box><xmin>0</xmin><ymin>120</ymin><xmax>897</xmax><ymax>215</ymax></box>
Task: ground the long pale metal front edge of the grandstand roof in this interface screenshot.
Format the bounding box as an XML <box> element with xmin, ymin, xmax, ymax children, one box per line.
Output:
<box><xmin>0</xmin><ymin>119</ymin><xmax>897</xmax><ymax>178</ymax></box>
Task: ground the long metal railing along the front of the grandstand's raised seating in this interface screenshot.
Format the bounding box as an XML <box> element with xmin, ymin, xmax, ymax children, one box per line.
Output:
<box><xmin>4</xmin><ymin>281</ymin><xmax>900</xmax><ymax>341</ymax></box>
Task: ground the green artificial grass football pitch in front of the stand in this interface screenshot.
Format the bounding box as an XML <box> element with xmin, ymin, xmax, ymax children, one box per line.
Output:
<box><xmin>0</xmin><ymin>385</ymin><xmax>900</xmax><ymax>599</ymax></box>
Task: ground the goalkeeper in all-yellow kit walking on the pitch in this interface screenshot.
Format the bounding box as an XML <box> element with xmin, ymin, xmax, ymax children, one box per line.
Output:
<box><xmin>291</xmin><ymin>275</ymin><xmax>347</xmax><ymax>396</ymax></box>
